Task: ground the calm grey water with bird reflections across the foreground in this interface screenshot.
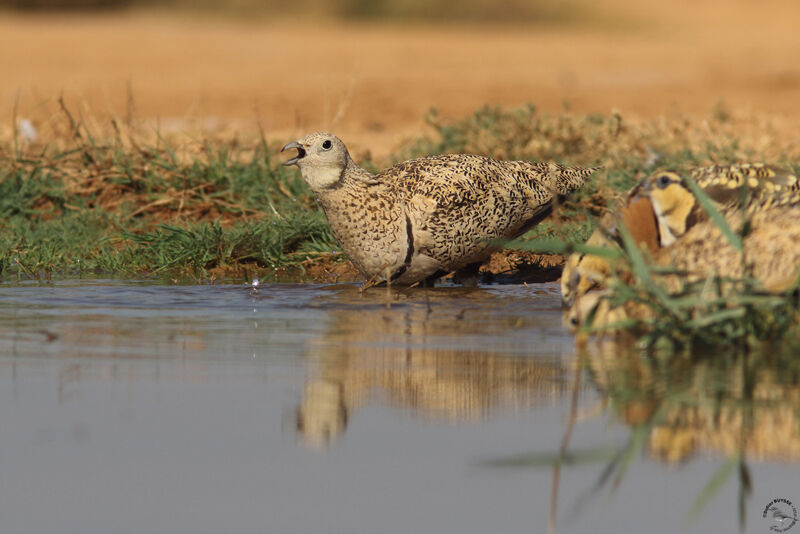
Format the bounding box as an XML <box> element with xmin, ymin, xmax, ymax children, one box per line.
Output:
<box><xmin>0</xmin><ymin>281</ymin><xmax>800</xmax><ymax>534</ymax></box>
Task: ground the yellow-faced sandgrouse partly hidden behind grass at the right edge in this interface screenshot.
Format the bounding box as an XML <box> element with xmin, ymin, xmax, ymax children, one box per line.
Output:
<box><xmin>562</xmin><ymin>164</ymin><xmax>800</xmax><ymax>326</ymax></box>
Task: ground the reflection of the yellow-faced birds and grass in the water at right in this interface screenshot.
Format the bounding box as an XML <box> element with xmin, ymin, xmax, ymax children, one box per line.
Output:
<box><xmin>584</xmin><ymin>341</ymin><xmax>800</xmax><ymax>464</ymax></box>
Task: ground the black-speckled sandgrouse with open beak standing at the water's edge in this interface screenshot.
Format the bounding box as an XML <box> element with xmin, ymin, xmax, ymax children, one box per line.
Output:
<box><xmin>282</xmin><ymin>132</ymin><xmax>596</xmax><ymax>285</ymax></box>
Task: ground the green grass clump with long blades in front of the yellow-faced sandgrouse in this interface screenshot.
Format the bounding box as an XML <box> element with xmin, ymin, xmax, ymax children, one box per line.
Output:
<box><xmin>521</xmin><ymin>176</ymin><xmax>800</xmax><ymax>355</ymax></box>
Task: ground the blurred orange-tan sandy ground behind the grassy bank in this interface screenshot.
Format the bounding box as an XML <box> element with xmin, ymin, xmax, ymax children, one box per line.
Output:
<box><xmin>0</xmin><ymin>0</ymin><xmax>800</xmax><ymax>155</ymax></box>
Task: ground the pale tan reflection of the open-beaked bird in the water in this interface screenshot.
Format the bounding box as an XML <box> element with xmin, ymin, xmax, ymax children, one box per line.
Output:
<box><xmin>296</xmin><ymin>286</ymin><xmax>573</xmax><ymax>446</ymax></box>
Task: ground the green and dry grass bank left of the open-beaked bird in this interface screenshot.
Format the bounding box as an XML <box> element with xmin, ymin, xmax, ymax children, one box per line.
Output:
<box><xmin>0</xmin><ymin>101</ymin><xmax>335</xmax><ymax>284</ymax></box>
